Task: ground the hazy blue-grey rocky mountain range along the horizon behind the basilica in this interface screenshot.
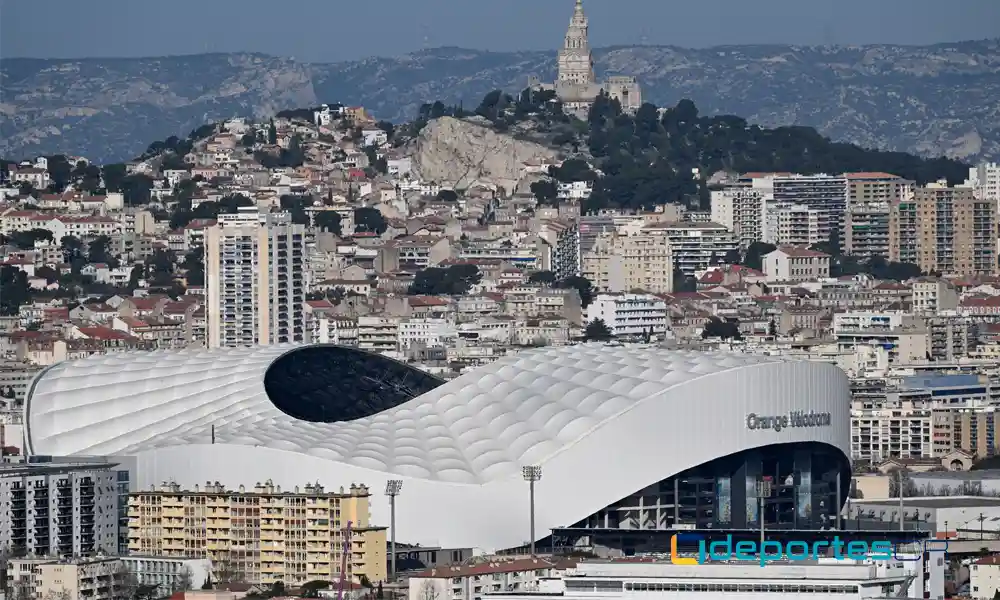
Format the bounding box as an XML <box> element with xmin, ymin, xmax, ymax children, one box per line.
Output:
<box><xmin>0</xmin><ymin>40</ymin><xmax>1000</xmax><ymax>160</ymax></box>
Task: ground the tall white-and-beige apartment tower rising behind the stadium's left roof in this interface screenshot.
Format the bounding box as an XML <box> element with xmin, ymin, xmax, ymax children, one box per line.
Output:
<box><xmin>205</xmin><ymin>207</ymin><xmax>306</xmax><ymax>348</ymax></box>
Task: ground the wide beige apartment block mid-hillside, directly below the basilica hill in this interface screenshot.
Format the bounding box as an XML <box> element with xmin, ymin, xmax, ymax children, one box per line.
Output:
<box><xmin>581</xmin><ymin>229</ymin><xmax>674</xmax><ymax>294</ymax></box>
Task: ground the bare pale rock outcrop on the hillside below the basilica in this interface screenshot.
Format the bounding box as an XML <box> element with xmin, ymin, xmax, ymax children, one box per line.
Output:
<box><xmin>413</xmin><ymin>117</ymin><xmax>558</xmax><ymax>193</ymax></box>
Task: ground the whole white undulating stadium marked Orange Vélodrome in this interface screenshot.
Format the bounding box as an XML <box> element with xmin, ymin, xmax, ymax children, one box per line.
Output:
<box><xmin>25</xmin><ymin>344</ymin><xmax>850</xmax><ymax>549</ymax></box>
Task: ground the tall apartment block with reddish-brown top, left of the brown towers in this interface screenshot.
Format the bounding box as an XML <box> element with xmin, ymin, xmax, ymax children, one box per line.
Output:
<box><xmin>841</xmin><ymin>173</ymin><xmax>913</xmax><ymax>258</ymax></box>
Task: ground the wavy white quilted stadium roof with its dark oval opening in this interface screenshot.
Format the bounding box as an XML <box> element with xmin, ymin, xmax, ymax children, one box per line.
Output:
<box><xmin>26</xmin><ymin>345</ymin><xmax>800</xmax><ymax>483</ymax></box>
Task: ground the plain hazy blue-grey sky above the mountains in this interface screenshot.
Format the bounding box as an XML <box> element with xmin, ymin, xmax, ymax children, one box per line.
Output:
<box><xmin>0</xmin><ymin>0</ymin><xmax>1000</xmax><ymax>61</ymax></box>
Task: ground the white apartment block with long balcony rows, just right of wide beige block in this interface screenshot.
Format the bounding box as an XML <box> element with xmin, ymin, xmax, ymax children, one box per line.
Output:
<box><xmin>638</xmin><ymin>222</ymin><xmax>738</xmax><ymax>276</ymax></box>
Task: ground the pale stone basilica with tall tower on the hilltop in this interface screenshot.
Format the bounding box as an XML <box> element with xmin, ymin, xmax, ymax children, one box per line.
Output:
<box><xmin>529</xmin><ymin>0</ymin><xmax>642</xmax><ymax>119</ymax></box>
